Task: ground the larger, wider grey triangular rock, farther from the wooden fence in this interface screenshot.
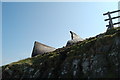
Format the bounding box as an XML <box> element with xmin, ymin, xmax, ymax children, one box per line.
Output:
<box><xmin>32</xmin><ymin>41</ymin><xmax>55</xmax><ymax>57</ymax></box>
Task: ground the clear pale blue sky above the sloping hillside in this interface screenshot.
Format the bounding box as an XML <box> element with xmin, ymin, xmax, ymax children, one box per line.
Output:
<box><xmin>2</xmin><ymin>2</ymin><xmax>118</xmax><ymax>65</ymax></box>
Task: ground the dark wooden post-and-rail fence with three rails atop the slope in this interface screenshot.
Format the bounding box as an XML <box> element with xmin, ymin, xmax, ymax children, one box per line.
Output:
<box><xmin>103</xmin><ymin>10</ymin><xmax>120</xmax><ymax>29</ymax></box>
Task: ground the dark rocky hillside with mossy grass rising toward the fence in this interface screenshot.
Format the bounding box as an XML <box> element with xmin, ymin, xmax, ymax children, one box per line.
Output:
<box><xmin>2</xmin><ymin>27</ymin><xmax>120</xmax><ymax>80</ymax></box>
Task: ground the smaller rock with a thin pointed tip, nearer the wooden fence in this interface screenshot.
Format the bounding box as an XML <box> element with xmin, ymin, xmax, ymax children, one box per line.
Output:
<box><xmin>66</xmin><ymin>31</ymin><xmax>83</xmax><ymax>46</ymax></box>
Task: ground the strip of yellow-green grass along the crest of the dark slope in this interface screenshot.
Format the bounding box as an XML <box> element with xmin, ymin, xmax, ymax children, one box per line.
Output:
<box><xmin>2</xmin><ymin>27</ymin><xmax>120</xmax><ymax>66</ymax></box>
